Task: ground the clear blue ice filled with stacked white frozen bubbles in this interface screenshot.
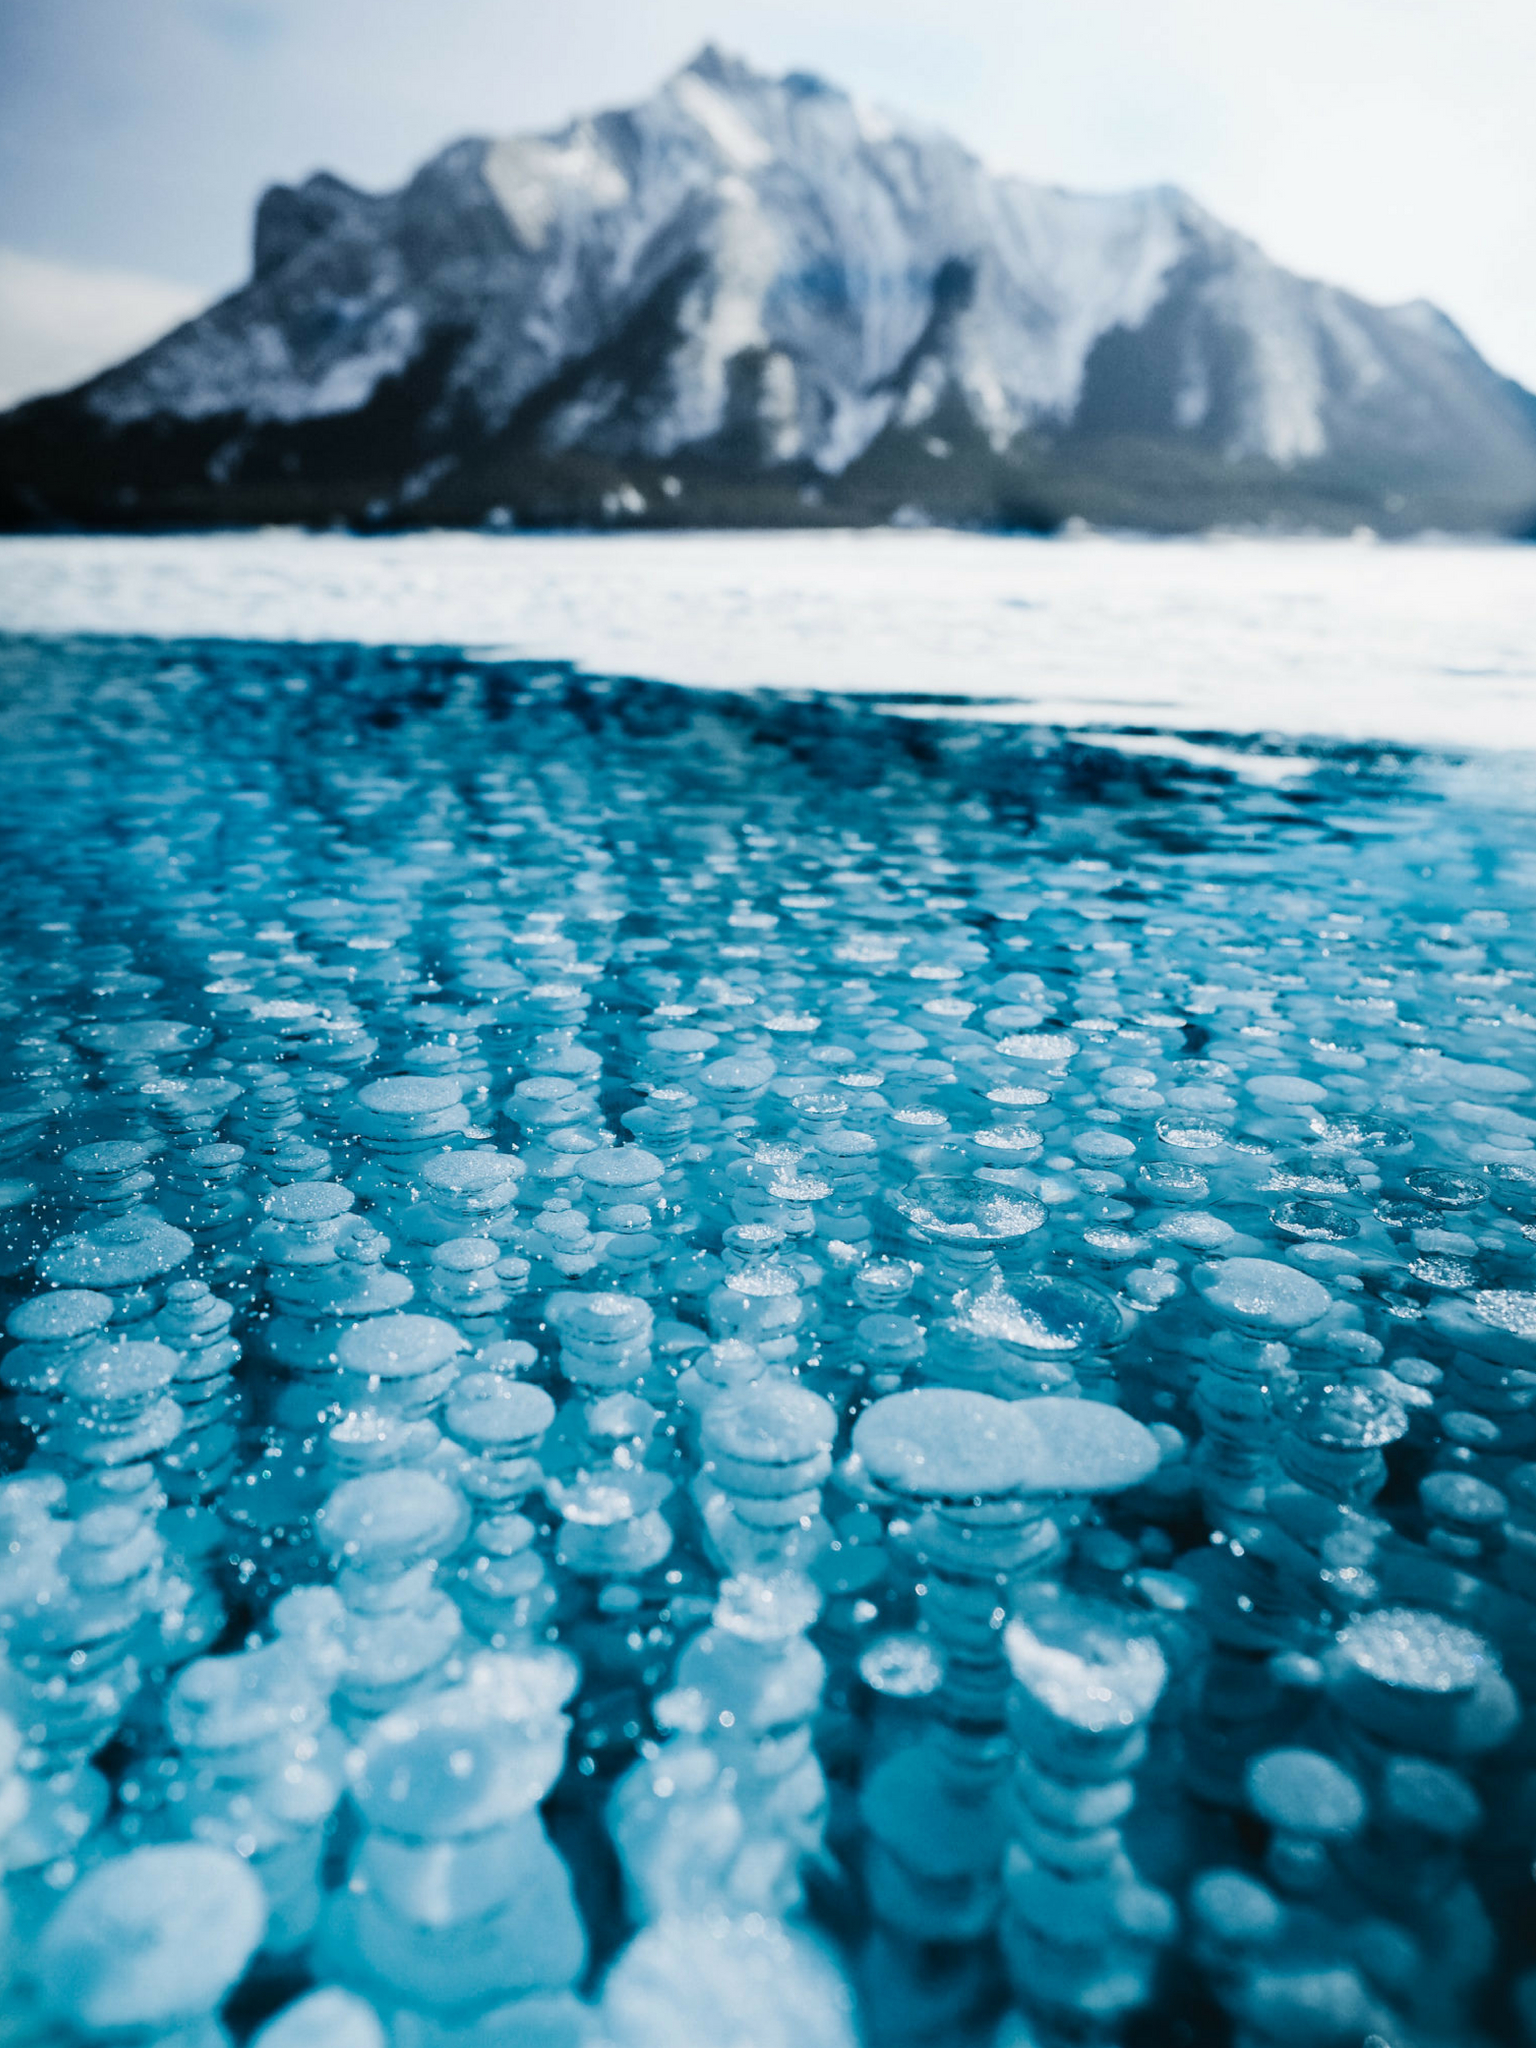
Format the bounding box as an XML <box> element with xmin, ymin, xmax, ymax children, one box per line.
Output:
<box><xmin>0</xmin><ymin>626</ymin><xmax>1536</xmax><ymax>2048</ymax></box>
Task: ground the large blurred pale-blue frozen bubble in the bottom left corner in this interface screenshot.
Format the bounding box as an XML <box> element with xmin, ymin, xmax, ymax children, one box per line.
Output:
<box><xmin>37</xmin><ymin>1841</ymin><xmax>266</xmax><ymax>2034</ymax></box>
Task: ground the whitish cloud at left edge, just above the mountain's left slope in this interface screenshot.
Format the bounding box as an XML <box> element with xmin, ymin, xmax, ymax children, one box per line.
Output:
<box><xmin>0</xmin><ymin>248</ymin><xmax>209</xmax><ymax>406</ymax></box>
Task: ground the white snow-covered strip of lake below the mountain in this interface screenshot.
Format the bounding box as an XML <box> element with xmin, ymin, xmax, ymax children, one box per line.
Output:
<box><xmin>0</xmin><ymin>530</ymin><xmax>1536</xmax><ymax>750</ymax></box>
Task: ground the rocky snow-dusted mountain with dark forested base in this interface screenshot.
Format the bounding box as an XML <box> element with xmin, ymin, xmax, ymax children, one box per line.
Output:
<box><xmin>0</xmin><ymin>49</ymin><xmax>1536</xmax><ymax>528</ymax></box>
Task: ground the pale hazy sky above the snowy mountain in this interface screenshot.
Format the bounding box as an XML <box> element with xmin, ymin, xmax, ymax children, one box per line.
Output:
<box><xmin>0</xmin><ymin>0</ymin><xmax>1536</xmax><ymax>403</ymax></box>
